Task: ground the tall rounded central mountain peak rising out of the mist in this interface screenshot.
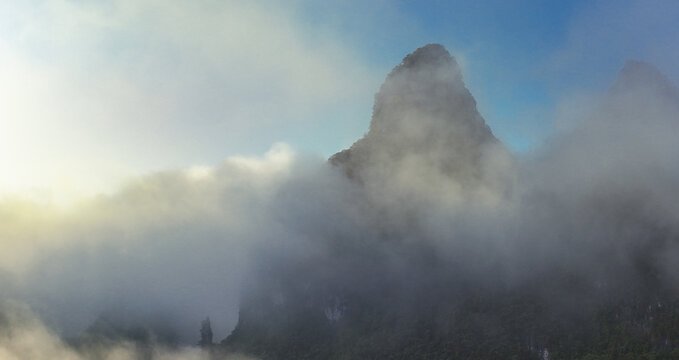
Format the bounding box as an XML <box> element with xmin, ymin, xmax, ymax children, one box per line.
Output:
<box><xmin>330</xmin><ymin>44</ymin><xmax>498</xmax><ymax>183</ymax></box>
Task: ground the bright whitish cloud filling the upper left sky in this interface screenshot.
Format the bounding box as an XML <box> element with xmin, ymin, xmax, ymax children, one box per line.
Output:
<box><xmin>0</xmin><ymin>0</ymin><xmax>371</xmax><ymax>203</ymax></box>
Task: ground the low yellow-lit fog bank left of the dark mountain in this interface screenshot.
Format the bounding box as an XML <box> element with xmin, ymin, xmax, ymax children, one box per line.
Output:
<box><xmin>0</xmin><ymin>144</ymin><xmax>295</xmax><ymax>343</ymax></box>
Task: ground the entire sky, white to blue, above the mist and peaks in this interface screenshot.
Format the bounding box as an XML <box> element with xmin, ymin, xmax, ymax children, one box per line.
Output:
<box><xmin>0</xmin><ymin>0</ymin><xmax>679</xmax><ymax>204</ymax></box>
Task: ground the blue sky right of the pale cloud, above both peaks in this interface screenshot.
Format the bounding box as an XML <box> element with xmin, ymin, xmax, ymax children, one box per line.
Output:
<box><xmin>288</xmin><ymin>0</ymin><xmax>679</xmax><ymax>154</ymax></box>
